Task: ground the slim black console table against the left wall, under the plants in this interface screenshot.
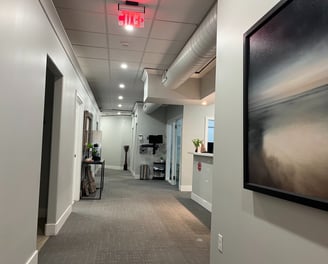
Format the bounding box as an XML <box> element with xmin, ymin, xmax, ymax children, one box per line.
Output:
<box><xmin>80</xmin><ymin>160</ymin><xmax>105</xmax><ymax>200</ymax></box>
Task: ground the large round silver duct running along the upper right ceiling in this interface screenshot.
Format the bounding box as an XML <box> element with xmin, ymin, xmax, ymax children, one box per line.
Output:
<box><xmin>162</xmin><ymin>4</ymin><xmax>217</xmax><ymax>89</ymax></box>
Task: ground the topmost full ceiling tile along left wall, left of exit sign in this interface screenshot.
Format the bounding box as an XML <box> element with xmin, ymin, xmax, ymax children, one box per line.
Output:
<box><xmin>58</xmin><ymin>8</ymin><xmax>106</xmax><ymax>33</ymax></box>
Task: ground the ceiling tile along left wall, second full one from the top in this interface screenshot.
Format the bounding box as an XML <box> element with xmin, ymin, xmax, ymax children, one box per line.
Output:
<box><xmin>66</xmin><ymin>30</ymin><xmax>107</xmax><ymax>48</ymax></box>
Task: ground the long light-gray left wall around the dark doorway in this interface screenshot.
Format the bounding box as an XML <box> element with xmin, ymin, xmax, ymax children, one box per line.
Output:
<box><xmin>0</xmin><ymin>0</ymin><xmax>98</xmax><ymax>264</ymax></box>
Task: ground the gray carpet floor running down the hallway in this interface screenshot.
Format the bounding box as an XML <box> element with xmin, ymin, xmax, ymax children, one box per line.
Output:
<box><xmin>39</xmin><ymin>170</ymin><xmax>210</xmax><ymax>264</ymax></box>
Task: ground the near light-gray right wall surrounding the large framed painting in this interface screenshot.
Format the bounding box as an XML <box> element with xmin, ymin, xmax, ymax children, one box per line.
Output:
<box><xmin>211</xmin><ymin>0</ymin><xmax>328</xmax><ymax>264</ymax></box>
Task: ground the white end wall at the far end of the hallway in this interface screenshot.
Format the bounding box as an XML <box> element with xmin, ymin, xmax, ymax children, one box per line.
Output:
<box><xmin>101</xmin><ymin>116</ymin><xmax>132</xmax><ymax>169</ymax></box>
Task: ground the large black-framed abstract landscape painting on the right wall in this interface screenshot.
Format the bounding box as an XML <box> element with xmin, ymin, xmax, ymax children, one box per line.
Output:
<box><xmin>243</xmin><ymin>0</ymin><xmax>328</xmax><ymax>210</ymax></box>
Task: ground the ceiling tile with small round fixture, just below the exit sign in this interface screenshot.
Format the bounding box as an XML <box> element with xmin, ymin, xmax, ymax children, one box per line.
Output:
<box><xmin>108</xmin><ymin>34</ymin><xmax>147</xmax><ymax>51</ymax></box>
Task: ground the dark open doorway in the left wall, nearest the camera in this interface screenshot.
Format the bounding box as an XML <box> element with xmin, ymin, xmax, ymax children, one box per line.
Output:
<box><xmin>37</xmin><ymin>57</ymin><xmax>62</xmax><ymax>249</ymax></box>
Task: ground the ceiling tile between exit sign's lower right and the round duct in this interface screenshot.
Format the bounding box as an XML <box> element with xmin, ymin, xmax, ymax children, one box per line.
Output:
<box><xmin>150</xmin><ymin>21</ymin><xmax>196</xmax><ymax>41</ymax></box>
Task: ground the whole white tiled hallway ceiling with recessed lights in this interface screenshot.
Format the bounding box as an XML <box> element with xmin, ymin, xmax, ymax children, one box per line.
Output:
<box><xmin>53</xmin><ymin>0</ymin><xmax>216</xmax><ymax>111</ymax></box>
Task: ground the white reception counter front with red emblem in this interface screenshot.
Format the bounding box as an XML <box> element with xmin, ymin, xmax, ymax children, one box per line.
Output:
<box><xmin>190</xmin><ymin>152</ymin><xmax>213</xmax><ymax>212</ymax></box>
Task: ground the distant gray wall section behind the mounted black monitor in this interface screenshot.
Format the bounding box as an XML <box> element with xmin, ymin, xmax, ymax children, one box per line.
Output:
<box><xmin>131</xmin><ymin>104</ymin><xmax>166</xmax><ymax>178</ymax></box>
